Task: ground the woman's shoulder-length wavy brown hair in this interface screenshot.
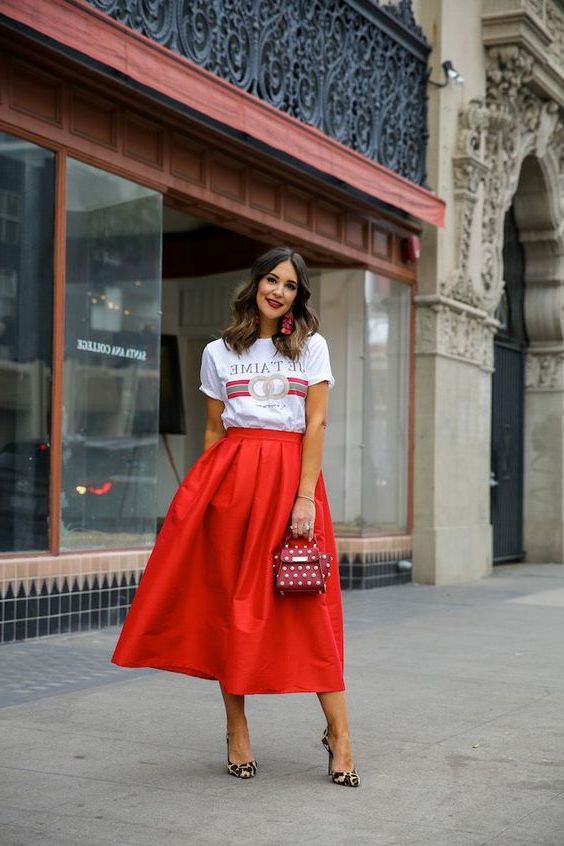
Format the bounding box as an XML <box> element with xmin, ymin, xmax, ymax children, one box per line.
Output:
<box><xmin>225</xmin><ymin>247</ymin><xmax>319</xmax><ymax>361</ymax></box>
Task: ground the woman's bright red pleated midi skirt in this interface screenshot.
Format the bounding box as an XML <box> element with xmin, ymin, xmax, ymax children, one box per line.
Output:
<box><xmin>111</xmin><ymin>428</ymin><xmax>345</xmax><ymax>694</ymax></box>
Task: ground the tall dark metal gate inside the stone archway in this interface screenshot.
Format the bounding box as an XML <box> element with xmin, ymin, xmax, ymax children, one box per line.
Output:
<box><xmin>490</xmin><ymin>206</ymin><xmax>528</xmax><ymax>564</ymax></box>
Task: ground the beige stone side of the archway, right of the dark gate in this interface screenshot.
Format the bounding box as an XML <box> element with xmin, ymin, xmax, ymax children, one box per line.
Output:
<box><xmin>513</xmin><ymin>154</ymin><xmax>564</xmax><ymax>561</ymax></box>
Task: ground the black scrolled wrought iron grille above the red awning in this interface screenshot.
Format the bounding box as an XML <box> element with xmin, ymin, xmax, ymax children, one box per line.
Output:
<box><xmin>82</xmin><ymin>0</ymin><xmax>429</xmax><ymax>184</ymax></box>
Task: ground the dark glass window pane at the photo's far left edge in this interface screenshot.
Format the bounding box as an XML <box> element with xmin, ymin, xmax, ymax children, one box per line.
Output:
<box><xmin>0</xmin><ymin>133</ymin><xmax>54</xmax><ymax>552</ymax></box>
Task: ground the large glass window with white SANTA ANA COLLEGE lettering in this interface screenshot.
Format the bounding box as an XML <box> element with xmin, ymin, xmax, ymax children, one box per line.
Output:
<box><xmin>61</xmin><ymin>159</ymin><xmax>162</xmax><ymax>549</ymax></box>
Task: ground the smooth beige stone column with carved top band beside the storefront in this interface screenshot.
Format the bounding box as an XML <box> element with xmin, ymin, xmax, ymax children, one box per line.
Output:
<box><xmin>413</xmin><ymin>295</ymin><xmax>495</xmax><ymax>584</ymax></box>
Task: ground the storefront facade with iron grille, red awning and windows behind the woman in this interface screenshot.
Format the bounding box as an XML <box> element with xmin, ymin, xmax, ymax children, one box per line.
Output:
<box><xmin>0</xmin><ymin>0</ymin><xmax>446</xmax><ymax>641</ymax></box>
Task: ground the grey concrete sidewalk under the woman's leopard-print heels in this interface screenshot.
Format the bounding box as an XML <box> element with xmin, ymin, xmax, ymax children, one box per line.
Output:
<box><xmin>0</xmin><ymin>565</ymin><xmax>564</xmax><ymax>846</ymax></box>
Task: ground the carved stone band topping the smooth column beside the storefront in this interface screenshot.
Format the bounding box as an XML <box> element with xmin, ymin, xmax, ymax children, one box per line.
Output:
<box><xmin>415</xmin><ymin>295</ymin><xmax>497</xmax><ymax>371</ymax></box>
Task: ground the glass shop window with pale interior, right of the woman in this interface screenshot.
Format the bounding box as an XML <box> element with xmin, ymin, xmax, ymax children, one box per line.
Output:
<box><xmin>312</xmin><ymin>269</ymin><xmax>410</xmax><ymax>534</ymax></box>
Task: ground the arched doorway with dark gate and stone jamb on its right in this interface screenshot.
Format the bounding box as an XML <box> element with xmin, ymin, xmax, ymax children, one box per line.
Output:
<box><xmin>491</xmin><ymin>149</ymin><xmax>564</xmax><ymax>563</ymax></box>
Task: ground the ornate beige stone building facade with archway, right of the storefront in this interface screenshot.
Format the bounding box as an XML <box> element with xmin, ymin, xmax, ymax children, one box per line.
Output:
<box><xmin>413</xmin><ymin>0</ymin><xmax>564</xmax><ymax>583</ymax></box>
